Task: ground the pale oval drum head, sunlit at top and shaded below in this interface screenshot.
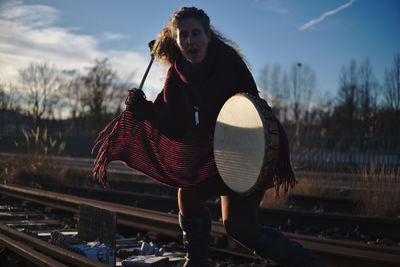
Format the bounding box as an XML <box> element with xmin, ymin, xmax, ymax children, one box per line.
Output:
<box><xmin>214</xmin><ymin>94</ymin><xmax>266</xmax><ymax>193</ymax></box>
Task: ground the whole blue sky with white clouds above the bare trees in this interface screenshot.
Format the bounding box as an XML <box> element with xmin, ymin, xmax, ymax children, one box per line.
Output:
<box><xmin>0</xmin><ymin>0</ymin><xmax>400</xmax><ymax>102</ymax></box>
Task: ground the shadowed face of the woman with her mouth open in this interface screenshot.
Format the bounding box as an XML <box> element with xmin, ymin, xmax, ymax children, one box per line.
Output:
<box><xmin>176</xmin><ymin>18</ymin><xmax>210</xmax><ymax>64</ymax></box>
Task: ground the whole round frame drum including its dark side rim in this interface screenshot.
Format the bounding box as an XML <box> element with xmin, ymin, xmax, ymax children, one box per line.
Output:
<box><xmin>214</xmin><ymin>93</ymin><xmax>279</xmax><ymax>194</ymax></box>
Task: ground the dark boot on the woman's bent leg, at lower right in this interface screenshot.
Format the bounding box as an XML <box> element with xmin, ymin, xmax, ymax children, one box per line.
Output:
<box><xmin>254</xmin><ymin>227</ymin><xmax>328</xmax><ymax>267</ymax></box>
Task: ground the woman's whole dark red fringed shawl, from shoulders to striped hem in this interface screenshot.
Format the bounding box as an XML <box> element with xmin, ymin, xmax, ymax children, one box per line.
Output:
<box><xmin>92</xmin><ymin>40</ymin><xmax>296</xmax><ymax>197</ymax></box>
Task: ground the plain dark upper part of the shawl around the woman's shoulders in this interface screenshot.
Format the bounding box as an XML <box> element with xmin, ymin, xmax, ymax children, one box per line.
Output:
<box><xmin>148</xmin><ymin>40</ymin><xmax>258</xmax><ymax>138</ymax></box>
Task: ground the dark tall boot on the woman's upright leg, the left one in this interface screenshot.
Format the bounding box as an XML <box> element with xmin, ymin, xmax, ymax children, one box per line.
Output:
<box><xmin>179</xmin><ymin>211</ymin><xmax>211</xmax><ymax>267</ymax></box>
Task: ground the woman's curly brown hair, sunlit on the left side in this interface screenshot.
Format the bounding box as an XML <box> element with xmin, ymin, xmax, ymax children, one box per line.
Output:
<box><xmin>151</xmin><ymin>7</ymin><xmax>243</xmax><ymax>65</ymax></box>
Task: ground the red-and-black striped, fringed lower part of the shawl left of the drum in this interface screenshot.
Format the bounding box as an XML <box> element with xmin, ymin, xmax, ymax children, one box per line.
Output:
<box><xmin>93</xmin><ymin>109</ymin><xmax>218</xmax><ymax>188</ymax></box>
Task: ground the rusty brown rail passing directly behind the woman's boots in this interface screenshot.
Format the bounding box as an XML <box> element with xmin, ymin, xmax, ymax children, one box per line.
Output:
<box><xmin>0</xmin><ymin>185</ymin><xmax>400</xmax><ymax>266</ymax></box>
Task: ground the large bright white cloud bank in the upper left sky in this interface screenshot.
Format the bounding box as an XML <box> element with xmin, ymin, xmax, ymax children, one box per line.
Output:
<box><xmin>0</xmin><ymin>0</ymin><xmax>163</xmax><ymax>99</ymax></box>
